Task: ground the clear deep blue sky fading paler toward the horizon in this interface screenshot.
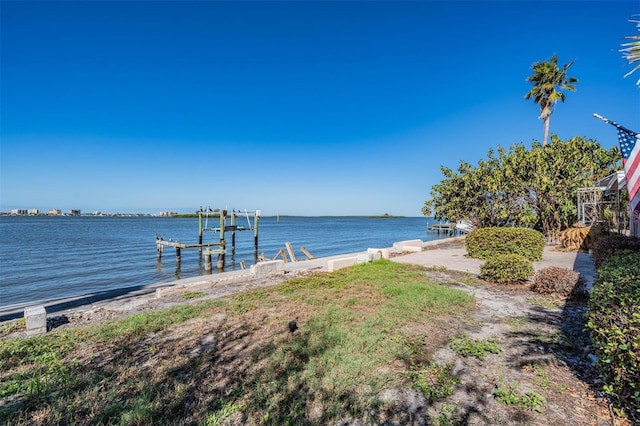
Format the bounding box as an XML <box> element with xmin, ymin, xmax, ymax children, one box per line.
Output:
<box><xmin>0</xmin><ymin>0</ymin><xmax>640</xmax><ymax>216</ymax></box>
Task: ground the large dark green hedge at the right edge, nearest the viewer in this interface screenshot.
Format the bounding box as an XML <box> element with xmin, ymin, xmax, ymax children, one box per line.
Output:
<box><xmin>587</xmin><ymin>252</ymin><xmax>640</xmax><ymax>421</ymax></box>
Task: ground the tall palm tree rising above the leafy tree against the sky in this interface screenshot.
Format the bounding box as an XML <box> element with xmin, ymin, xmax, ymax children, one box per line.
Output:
<box><xmin>524</xmin><ymin>54</ymin><xmax>578</xmax><ymax>145</ymax></box>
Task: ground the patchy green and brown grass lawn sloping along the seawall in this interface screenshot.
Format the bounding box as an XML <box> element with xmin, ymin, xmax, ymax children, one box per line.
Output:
<box><xmin>0</xmin><ymin>260</ymin><xmax>474</xmax><ymax>425</ymax></box>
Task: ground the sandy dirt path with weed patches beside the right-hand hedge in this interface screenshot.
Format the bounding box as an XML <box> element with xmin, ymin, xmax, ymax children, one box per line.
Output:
<box><xmin>420</xmin><ymin>272</ymin><xmax>630</xmax><ymax>426</ymax></box>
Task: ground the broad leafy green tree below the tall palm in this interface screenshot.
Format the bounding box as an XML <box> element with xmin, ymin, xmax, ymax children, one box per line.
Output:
<box><xmin>422</xmin><ymin>135</ymin><xmax>620</xmax><ymax>237</ymax></box>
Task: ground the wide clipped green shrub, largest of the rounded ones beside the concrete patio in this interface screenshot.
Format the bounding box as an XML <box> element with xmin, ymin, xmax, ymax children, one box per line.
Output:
<box><xmin>465</xmin><ymin>228</ymin><xmax>545</xmax><ymax>260</ymax></box>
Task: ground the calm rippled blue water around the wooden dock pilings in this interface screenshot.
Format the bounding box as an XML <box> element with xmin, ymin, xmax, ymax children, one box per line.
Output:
<box><xmin>0</xmin><ymin>216</ymin><xmax>450</xmax><ymax>306</ymax></box>
